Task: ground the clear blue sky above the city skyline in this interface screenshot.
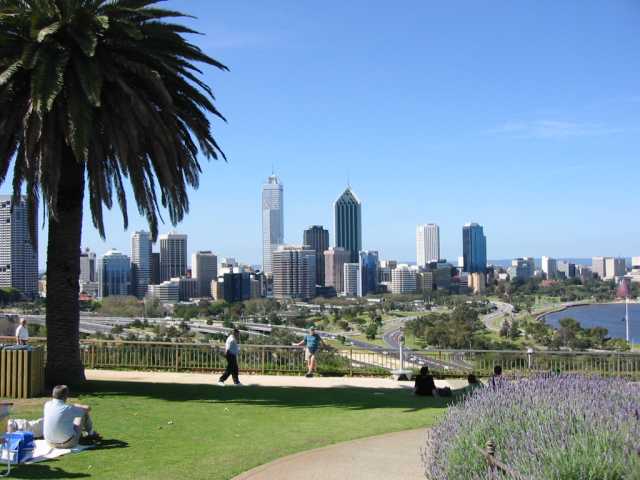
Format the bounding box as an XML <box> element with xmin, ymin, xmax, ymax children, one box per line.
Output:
<box><xmin>38</xmin><ymin>0</ymin><xmax>640</xmax><ymax>263</ymax></box>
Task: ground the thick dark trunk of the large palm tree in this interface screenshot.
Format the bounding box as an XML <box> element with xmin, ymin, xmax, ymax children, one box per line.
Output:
<box><xmin>46</xmin><ymin>151</ymin><xmax>85</xmax><ymax>386</ymax></box>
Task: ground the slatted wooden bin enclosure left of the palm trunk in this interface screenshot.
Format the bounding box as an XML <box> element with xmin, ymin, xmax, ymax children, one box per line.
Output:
<box><xmin>0</xmin><ymin>348</ymin><xmax>44</xmax><ymax>398</ymax></box>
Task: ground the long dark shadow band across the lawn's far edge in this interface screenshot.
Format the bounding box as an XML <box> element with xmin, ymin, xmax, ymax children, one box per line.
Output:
<box><xmin>78</xmin><ymin>381</ymin><xmax>456</xmax><ymax>411</ymax></box>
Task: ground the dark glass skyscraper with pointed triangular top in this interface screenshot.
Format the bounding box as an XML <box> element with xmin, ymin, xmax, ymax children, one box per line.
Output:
<box><xmin>333</xmin><ymin>187</ymin><xmax>362</xmax><ymax>263</ymax></box>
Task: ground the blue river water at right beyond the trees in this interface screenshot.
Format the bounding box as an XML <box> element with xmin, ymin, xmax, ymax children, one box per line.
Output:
<box><xmin>545</xmin><ymin>303</ymin><xmax>640</xmax><ymax>343</ymax></box>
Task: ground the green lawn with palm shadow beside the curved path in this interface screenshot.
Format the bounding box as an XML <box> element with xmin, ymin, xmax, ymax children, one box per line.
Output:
<box><xmin>12</xmin><ymin>382</ymin><xmax>446</xmax><ymax>480</ymax></box>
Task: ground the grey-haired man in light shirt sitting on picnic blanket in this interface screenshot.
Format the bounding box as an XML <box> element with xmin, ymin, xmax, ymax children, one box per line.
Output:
<box><xmin>43</xmin><ymin>385</ymin><xmax>100</xmax><ymax>448</ymax></box>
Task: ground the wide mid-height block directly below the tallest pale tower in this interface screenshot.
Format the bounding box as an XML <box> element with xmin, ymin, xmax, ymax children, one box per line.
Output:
<box><xmin>273</xmin><ymin>245</ymin><xmax>316</xmax><ymax>300</ymax></box>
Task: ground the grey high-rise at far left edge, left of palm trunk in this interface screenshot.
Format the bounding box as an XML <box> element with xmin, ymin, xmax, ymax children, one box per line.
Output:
<box><xmin>0</xmin><ymin>195</ymin><xmax>38</xmax><ymax>298</ymax></box>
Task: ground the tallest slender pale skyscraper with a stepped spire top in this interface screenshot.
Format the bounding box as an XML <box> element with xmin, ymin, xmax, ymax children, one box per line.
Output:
<box><xmin>262</xmin><ymin>175</ymin><xmax>284</xmax><ymax>275</ymax></box>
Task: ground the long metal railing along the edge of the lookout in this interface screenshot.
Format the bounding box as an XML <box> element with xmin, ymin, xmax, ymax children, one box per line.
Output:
<box><xmin>5</xmin><ymin>337</ymin><xmax>640</xmax><ymax>379</ymax></box>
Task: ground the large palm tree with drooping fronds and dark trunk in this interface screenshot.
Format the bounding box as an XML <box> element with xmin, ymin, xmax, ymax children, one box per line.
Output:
<box><xmin>0</xmin><ymin>0</ymin><xmax>226</xmax><ymax>384</ymax></box>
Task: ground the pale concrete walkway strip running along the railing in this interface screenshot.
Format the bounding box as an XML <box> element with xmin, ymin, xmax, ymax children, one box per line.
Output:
<box><xmin>85</xmin><ymin>370</ymin><xmax>467</xmax><ymax>389</ymax></box>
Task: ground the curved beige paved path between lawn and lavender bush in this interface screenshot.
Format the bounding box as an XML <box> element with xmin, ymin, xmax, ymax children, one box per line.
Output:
<box><xmin>233</xmin><ymin>428</ymin><xmax>426</xmax><ymax>480</ymax></box>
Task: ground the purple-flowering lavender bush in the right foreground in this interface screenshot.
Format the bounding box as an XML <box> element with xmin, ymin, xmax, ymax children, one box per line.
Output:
<box><xmin>423</xmin><ymin>375</ymin><xmax>640</xmax><ymax>480</ymax></box>
